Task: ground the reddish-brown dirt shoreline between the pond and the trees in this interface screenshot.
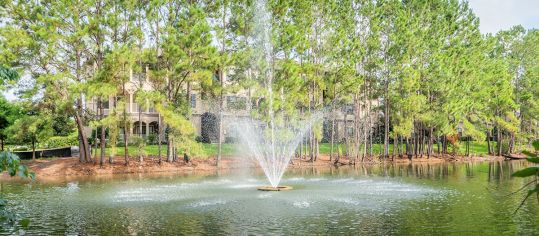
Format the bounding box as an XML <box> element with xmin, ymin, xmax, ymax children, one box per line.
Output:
<box><xmin>7</xmin><ymin>156</ymin><xmax>504</xmax><ymax>179</ymax></box>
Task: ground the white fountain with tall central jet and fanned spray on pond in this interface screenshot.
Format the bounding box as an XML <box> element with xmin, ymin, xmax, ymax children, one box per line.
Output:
<box><xmin>236</xmin><ymin>0</ymin><xmax>319</xmax><ymax>191</ymax></box>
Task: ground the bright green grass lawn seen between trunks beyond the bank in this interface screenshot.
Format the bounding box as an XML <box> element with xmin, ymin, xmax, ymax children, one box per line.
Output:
<box><xmin>99</xmin><ymin>142</ymin><xmax>496</xmax><ymax>158</ymax></box>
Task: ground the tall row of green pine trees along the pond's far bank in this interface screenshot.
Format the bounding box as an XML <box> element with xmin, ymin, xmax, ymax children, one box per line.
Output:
<box><xmin>0</xmin><ymin>0</ymin><xmax>539</xmax><ymax>164</ymax></box>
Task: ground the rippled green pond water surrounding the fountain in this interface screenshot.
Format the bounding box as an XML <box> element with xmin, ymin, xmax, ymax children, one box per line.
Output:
<box><xmin>0</xmin><ymin>159</ymin><xmax>539</xmax><ymax>235</ymax></box>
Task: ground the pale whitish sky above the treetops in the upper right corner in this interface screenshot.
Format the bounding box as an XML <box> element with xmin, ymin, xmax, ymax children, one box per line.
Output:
<box><xmin>469</xmin><ymin>0</ymin><xmax>539</xmax><ymax>33</ymax></box>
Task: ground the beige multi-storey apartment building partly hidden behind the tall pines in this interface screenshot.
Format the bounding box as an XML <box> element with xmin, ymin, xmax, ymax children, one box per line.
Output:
<box><xmin>86</xmin><ymin>68</ymin><xmax>378</xmax><ymax>142</ymax></box>
